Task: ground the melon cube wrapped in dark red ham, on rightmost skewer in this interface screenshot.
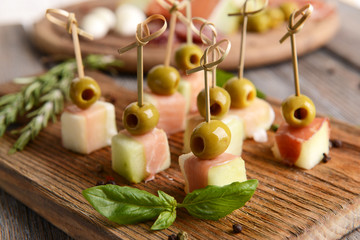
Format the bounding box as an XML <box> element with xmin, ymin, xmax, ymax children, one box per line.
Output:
<box><xmin>272</xmin><ymin>118</ymin><xmax>330</xmax><ymax>169</ymax></box>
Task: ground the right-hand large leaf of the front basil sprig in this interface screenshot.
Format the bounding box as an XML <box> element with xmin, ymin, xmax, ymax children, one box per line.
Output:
<box><xmin>178</xmin><ymin>179</ymin><xmax>258</xmax><ymax>220</ymax></box>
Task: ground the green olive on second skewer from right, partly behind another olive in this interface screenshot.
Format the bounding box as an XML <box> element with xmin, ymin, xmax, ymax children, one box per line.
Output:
<box><xmin>224</xmin><ymin>77</ymin><xmax>256</xmax><ymax>108</ymax></box>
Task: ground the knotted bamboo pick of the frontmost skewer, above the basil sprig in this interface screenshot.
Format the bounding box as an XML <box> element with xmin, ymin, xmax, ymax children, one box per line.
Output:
<box><xmin>186</xmin><ymin>39</ymin><xmax>231</xmax><ymax>122</ymax></box>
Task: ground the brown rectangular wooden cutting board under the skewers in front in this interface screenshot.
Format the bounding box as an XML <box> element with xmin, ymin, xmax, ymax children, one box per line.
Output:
<box><xmin>0</xmin><ymin>72</ymin><xmax>360</xmax><ymax>239</ymax></box>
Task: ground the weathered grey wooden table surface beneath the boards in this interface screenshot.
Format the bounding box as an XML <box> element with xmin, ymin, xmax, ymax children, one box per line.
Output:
<box><xmin>0</xmin><ymin>3</ymin><xmax>360</xmax><ymax>239</ymax></box>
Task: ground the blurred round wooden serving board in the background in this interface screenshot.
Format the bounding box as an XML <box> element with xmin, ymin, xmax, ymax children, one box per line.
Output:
<box><xmin>32</xmin><ymin>0</ymin><xmax>339</xmax><ymax>72</ymax></box>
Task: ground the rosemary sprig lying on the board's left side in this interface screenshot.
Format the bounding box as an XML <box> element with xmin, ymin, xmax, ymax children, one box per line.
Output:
<box><xmin>0</xmin><ymin>55</ymin><xmax>121</xmax><ymax>153</ymax></box>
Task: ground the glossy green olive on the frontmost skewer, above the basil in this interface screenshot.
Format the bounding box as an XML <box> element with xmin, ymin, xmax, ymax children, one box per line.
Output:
<box><xmin>190</xmin><ymin>120</ymin><xmax>231</xmax><ymax>159</ymax></box>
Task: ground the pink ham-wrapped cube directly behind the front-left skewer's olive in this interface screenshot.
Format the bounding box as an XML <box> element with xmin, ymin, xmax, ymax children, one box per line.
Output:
<box><xmin>144</xmin><ymin>92</ymin><xmax>187</xmax><ymax>134</ymax></box>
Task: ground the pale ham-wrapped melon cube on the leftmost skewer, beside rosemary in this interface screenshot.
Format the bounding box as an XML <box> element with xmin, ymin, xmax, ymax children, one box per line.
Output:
<box><xmin>61</xmin><ymin>101</ymin><xmax>117</xmax><ymax>154</ymax></box>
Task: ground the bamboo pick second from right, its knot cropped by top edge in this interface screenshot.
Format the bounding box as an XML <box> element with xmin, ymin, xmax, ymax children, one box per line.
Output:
<box><xmin>228</xmin><ymin>0</ymin><xmax>268</xmax><ymax>79</ymax></box>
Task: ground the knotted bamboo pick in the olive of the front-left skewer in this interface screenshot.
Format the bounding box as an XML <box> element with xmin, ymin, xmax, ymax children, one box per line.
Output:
<box><xmin>118</xmin><ymin>14</ymin><xmax>167</xmax><ymax>107</ymax></box>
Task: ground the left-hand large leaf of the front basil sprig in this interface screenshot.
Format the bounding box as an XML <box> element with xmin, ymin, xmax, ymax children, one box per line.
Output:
<box><xmin>82</xmin><ymin>184</ymin><xmax>171</xmax><ymax>224</ymax></box>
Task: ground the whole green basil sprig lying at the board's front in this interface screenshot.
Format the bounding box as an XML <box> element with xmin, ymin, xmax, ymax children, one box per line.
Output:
<box><xmin>82</xmin><ymin>179</ymin><xmax>258</xmax><ymax>230</ymax></box>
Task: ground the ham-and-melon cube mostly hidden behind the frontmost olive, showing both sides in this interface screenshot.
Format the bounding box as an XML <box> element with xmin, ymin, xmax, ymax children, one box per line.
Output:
<box><xmin>183</xmin><ymin>114</ymin><xmax>245</xmax><ymax>156</ymax></box>
